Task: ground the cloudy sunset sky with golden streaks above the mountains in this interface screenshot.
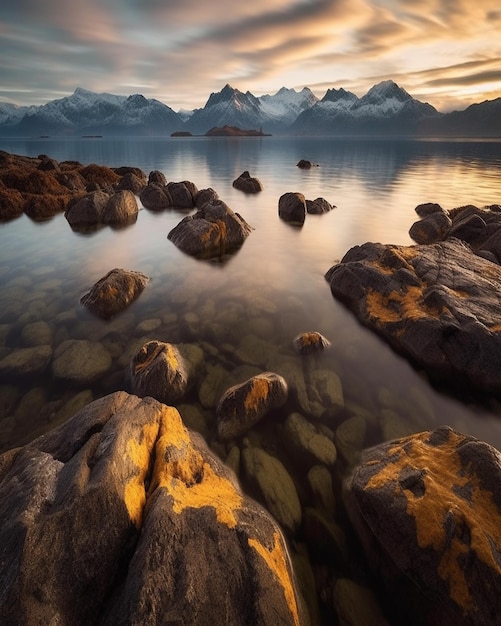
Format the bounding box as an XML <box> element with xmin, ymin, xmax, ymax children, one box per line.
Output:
<box><xmin>0</xmin><ymin>0</ymin><xmax>501</xmax><ymax>112</ymax></box>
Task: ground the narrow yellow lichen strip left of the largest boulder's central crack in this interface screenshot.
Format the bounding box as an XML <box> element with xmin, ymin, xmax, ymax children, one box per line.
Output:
<box><xmin>124</xmin><ymin>422</ymin><xmax>158</xmax><ymax>528</ymax></box>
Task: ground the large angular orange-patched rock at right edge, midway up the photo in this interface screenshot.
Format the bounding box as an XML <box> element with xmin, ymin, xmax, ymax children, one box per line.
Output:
<box><xmin>326</xmin><ymin>239</ymin><xmax>501</xmax><ymax>393</ymax></box>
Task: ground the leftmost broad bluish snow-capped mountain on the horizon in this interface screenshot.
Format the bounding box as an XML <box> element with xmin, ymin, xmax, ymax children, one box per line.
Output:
<box><xmin>2</xmin><ymin>87</ymin><xmax>182</xmax><ymax>135</ymax></box>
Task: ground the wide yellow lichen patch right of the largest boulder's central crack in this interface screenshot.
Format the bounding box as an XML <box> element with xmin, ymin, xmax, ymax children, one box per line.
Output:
<box><xmin>150</xmin><ymin>407</ymin><xmax>242</xmax><ymax>528</ymax></box>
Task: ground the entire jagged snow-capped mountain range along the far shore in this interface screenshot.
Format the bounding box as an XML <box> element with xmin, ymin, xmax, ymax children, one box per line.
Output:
<box><xmin>0</xmin><ymin>80</ymin><xmax>501</xmax><ymax>137</ymax></box>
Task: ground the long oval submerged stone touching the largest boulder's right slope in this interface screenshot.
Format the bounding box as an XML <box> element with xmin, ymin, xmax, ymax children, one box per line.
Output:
<box><xmin>241</xmin><ymin>446</ymin><xmax>301</xmax><ymax>535</ymax></box>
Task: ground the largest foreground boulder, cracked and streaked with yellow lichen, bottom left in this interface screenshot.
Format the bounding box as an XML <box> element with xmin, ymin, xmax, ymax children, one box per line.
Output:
<box><xmin>0</xmin><ymin>392</ymin><xmax>309</xmax><ymax>626</ymax></box>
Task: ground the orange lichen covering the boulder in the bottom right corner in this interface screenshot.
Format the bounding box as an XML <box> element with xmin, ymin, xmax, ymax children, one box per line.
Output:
<box><xmin>365</xmin><ymin>432</ymin><xmax>501</xmax><ymax>612</ymax></box>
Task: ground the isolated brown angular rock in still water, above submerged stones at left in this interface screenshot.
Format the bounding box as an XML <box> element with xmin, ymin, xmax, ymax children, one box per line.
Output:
<box><xmin>80</xmin><ymin>268</ymin><xmax>150</xmax><ymax>319</ymax></box>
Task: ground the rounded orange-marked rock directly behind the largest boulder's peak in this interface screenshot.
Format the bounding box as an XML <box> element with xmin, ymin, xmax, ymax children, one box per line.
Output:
<box><xmin>130</xmin><ymin>341</ymin><xmax>193</xmax><ymax>404</ymax></box>
